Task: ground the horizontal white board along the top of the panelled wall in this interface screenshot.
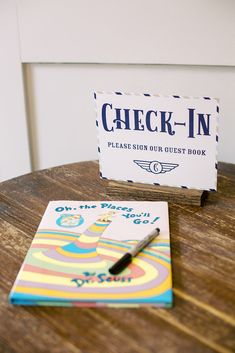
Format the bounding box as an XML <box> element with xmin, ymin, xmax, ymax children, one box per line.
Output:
<box><xmin>18</xmin><ymin>0</ymin><xmax>235</xmax><ymax>65</ymax></box>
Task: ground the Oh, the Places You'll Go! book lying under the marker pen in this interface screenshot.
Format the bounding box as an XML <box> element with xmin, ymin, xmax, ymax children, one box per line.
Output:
<box><xmin>9</xmin><ymin>201</ymin><xmax>172</xmax><ymax>307</ymax></box>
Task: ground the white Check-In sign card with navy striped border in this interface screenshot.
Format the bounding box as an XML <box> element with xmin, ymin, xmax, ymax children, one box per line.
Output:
<box><xmin>94</xmin><ymin>92</ymin><xmax>219</xmax><ymax>191</ymax></box>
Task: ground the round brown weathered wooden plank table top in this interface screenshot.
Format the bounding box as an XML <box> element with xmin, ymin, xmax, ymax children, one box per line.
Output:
<box><xmin>0</xmin><ymin>162</ymin><xmax>235</xmax><ymax>353</ymax></box>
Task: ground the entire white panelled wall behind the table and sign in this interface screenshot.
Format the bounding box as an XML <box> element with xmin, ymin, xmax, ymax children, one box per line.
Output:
<box><xmin>0</xmin><ymin>0</ymin><xmax>235</xmax><ymax>181</ymax></box>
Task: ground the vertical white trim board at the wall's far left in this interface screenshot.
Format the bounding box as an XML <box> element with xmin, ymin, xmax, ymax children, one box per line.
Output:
<box><xmin>0</xmin><ymin>0</ymin><xmax>31</xmax><ymax>181</ymax></box>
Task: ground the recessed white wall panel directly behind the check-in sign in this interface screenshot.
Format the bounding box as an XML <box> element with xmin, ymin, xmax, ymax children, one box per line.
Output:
<box><xmin>26</xmin><ymin>64</ymin><xmax>235</xmax><ymax>169</ymax></box>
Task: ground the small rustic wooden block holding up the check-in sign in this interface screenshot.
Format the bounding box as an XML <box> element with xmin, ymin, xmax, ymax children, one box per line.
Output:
<box><xmin>105</xmin><ymin>180</ymin><xmax>208</xmax><ymax>206</ymax></box>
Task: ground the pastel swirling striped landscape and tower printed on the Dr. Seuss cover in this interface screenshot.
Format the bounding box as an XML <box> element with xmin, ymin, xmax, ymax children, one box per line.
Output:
<box><xmin>10</xmin><ymin>212</ymin><xmax>172</xmax><ymax>306</ymax></box>
